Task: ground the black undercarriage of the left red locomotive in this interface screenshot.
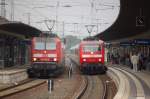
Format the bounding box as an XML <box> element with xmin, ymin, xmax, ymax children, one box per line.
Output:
<box><xmin>27</xmin><ymin>62</ymin><xmax>64</xmax><ymax>77</ymax></box>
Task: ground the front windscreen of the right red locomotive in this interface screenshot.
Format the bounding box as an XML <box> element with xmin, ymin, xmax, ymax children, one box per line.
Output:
<box><xmin>83</xmin><ymin>44</ymin><xmax>101</xmax><ymax>52</ymax></box>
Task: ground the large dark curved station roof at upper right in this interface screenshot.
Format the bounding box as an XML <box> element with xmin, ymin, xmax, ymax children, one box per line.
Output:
<box><xmin>95</xmin><ymin>0</ymin><xmax>150</xmax><ymax>41</ymax></box>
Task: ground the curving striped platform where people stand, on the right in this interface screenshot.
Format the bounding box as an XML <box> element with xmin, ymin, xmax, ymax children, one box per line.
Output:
<box><xmin>106</xmin><ymin>64</ymin><xmax>150</xmax><ymax>99</ymax></box>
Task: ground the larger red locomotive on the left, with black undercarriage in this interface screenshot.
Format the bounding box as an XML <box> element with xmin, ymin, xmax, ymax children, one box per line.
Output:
<box><xmin>27</xmin><ymin>36</ymin><xmax>65</xmax><ymax>77</ymax></box>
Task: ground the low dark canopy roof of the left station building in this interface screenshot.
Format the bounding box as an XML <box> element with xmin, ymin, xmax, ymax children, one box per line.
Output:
<box><xmin>0</xmin><ymin>17</ymin><xmax>41</xmax><ymax>37</ymax></box>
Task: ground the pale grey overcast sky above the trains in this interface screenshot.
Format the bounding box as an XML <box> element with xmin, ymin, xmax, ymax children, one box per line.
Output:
<box><xmin>3</xmin><ymin>0</ymin><xmax>120</xmax><ymax>38</ymax></box>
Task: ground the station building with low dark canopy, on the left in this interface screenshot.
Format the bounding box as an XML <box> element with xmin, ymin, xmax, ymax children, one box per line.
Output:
<box><xmin>0</xmin><ymin>17</ymin><xmax>41</xmax><ymax>69</ymax></box>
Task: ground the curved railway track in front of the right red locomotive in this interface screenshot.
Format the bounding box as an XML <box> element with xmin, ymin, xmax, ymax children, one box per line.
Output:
<box><xmin>72</xmin><ymin>75</ymin><xmax>117</xmax><ymax>99</ymax></box>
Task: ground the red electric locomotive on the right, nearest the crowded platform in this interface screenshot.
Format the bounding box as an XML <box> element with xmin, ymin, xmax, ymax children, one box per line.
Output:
<box><xmin>79</xmin><ymin>40</ymin><xmax>107</xmax><ymax>73</ymax></box>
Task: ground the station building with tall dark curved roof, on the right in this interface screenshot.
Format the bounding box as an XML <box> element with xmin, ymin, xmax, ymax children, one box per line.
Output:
<box><xmin>95</xmin><ymin>0</ymin><xmax>150</xmax><ymax>68</ymax></box>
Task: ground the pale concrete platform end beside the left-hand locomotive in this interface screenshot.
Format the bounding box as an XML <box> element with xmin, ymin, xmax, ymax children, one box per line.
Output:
<box><xmin>0</xmin><ymin>65</ymin><xmax>29</xmax><ymax>86</ymax></box>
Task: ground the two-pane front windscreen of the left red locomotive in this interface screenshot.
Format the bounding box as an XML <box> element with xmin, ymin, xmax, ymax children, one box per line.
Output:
<box><xmin>34</xmin><ymin>38</ymin><xmax>56</xmax><ymax>50</ymax></box>
